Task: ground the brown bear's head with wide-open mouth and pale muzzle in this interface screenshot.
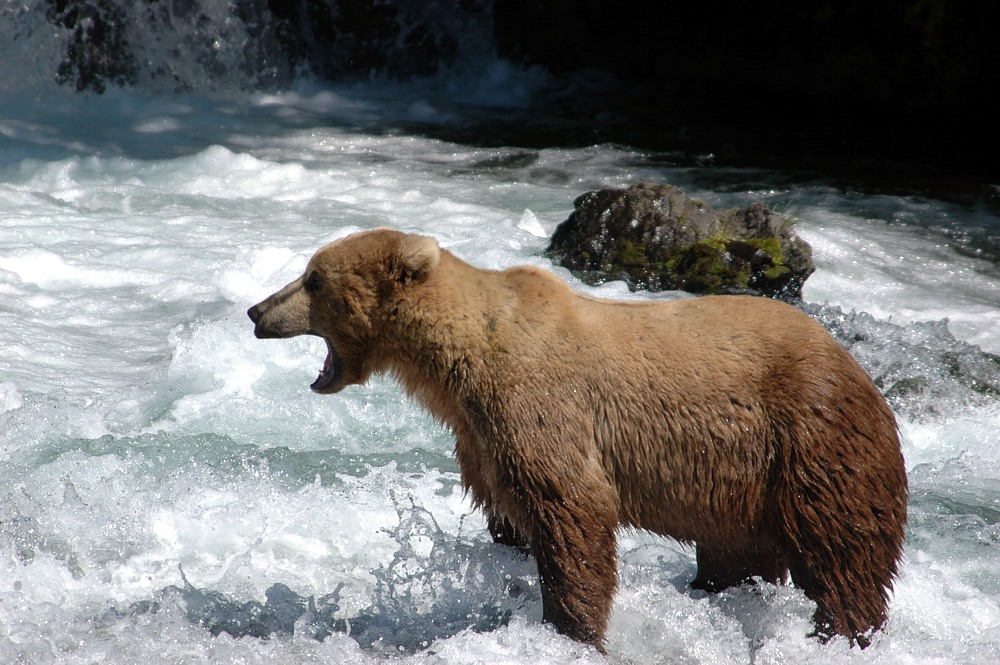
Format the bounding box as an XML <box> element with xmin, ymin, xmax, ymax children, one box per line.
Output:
<box><xmin>247</xmin><ymin>228</ymin><xmax>441</xmax><ymax>393</ymax></box>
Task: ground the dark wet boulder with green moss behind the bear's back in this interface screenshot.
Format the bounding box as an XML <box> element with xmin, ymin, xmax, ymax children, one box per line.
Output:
<box><xmin>547</xmin><ymin>183</ymin><xmax>815</xmax><ymax>299</ymax></box>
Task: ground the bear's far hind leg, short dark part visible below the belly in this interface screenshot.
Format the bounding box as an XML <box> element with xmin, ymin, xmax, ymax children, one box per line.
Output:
<box><xmin>691</xmin><ymin>543</ymin><xmax>788</xmax><ymax>593</ymax></box>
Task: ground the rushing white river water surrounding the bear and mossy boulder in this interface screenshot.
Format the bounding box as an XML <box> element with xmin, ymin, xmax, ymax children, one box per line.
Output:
<box><xmin>0</xmin><ymin>65</ymin><xmax>1000</xmax><ymax>664</ymax></box>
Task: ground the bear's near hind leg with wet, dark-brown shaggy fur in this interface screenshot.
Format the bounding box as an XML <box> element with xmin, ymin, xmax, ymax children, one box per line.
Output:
<box><xmin>778</xmin><ymin>416</ymin><xmax>907</xmax><ymax>647</ymax></box>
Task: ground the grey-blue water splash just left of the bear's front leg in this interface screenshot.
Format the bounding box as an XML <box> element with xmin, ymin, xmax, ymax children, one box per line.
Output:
<box><xmin>111</xmin><ymin>499</ymin><xmax>541</xmax><ymax>654</ymax></box>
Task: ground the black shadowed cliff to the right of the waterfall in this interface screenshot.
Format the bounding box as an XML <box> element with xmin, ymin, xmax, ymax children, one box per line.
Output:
<box><xmin>494</xmin><ymin>0</ymin><xmax>1000</xmax><ymax>179</ymax></box>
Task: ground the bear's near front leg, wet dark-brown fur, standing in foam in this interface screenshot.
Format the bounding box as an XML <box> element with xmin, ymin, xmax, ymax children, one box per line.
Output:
<box><xmin>531</xmin><ymin>474</ymin><xmax>618</xmax><ymax>653</ymax></box>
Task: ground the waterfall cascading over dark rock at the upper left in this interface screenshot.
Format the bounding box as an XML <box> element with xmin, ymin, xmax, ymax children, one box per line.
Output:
<box><xmin>0</xmin><ymin>0</ymin><xmax>493</xmax><ymax>93</ymax></box>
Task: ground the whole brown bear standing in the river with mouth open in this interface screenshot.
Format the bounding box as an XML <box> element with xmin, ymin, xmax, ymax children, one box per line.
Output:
<box><xmin>248</xmin><ymin>229</ymin><xmax>907</xmax><ymax>650</ymax></box>
